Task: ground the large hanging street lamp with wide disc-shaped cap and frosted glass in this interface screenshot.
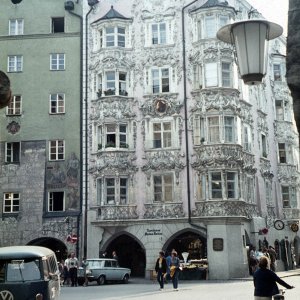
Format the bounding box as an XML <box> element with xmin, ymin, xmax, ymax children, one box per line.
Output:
<box><xmin>217</xmin><ymin>19</ymin><xmax>283</xmax><ymax>85</ymax></box>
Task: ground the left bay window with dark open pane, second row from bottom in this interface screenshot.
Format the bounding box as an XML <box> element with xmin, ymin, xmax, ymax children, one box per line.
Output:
<box><xmin>97</xmin><ymin>124</ymin><xmax>128</xmax><ymax>150</ymax></box>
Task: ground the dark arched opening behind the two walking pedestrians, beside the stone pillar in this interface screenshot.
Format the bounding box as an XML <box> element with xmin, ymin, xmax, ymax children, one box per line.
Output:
<box><xmin>164</xmin><ymin>231</ymin><xmax>207</xmax><ymax>260</ymax></box>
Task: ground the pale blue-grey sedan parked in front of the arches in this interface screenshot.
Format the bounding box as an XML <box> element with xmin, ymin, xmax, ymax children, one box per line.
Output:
<box><xmin>78</xmin><ymin>258</ymin><xmax>131</xmax><ymax>285</ymax></box>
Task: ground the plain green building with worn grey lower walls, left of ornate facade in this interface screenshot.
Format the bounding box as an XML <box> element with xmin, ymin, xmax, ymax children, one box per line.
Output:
<box><xmin>0</xmin><ymin>0</ymin><xmax>83</xmax><ymax>258</ymax></box>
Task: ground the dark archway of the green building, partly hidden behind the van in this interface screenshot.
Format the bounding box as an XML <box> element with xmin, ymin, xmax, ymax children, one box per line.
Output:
<box><xmin>28</xmin><ymin>237</ymin><xmax>68</xmax><ymax>261</ymax></box>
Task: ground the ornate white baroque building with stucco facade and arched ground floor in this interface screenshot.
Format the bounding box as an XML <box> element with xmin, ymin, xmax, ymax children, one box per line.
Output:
<box><xmin>84</xmin><ymin>0</ymin><xmax>300</xmax><ymax>279</ymax></box>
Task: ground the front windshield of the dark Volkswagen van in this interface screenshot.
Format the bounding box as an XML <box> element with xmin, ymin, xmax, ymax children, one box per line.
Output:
<box><xmin>0</xmin><ymin>258</ymin><xmax>42</xmax><ymax>282</ymax></box>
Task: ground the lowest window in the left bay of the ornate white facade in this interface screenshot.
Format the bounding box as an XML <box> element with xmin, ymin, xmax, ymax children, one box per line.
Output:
<box><xmin>97</xmin><ymin>177</ymin><xmax>128</xmax><ymax>205</ymax></box>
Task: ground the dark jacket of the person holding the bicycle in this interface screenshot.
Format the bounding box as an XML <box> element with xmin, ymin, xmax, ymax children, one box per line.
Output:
<box><xmin>253</xmin><ymin>268</ymin><xmax>292</xmax><ymax>297</ymax></box>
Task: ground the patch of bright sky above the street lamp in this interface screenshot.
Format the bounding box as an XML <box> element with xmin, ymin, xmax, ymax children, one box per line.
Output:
<box><xmin>247</xmin><ymin>0</ymin><xmax>289</xmax><ymax>35</ymax></box>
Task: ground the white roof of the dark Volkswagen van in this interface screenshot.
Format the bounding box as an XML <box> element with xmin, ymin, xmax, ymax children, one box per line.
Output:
<box><xmin>0</xmin><ymin>246</ymin><xmax>54</xmax><ymax>259</ymax></box>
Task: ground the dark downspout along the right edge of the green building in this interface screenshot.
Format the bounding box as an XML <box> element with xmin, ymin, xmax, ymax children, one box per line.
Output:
<box><xmin>68</xmin><ymin>10</ymin><xmax>83</xmax><ymax>256</ymax></box>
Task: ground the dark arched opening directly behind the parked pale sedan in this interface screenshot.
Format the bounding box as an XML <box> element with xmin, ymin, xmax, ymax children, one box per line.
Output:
<box><xmin>103</xmin><ymin>234</ymin><xmax>146</xmax><ymax>277</ymax></box>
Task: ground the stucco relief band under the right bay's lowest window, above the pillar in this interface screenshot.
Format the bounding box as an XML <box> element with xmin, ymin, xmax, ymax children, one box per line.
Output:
<box><xmin>192</xmin><ymin>200</ymin><xmax>259</xmax><ymax>219</ymax></box>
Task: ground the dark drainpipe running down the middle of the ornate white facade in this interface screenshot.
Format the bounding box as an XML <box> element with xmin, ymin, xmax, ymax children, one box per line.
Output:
<box><xmin>181</xmin><ymin>0</ymin><xmax>203</xmax><ymax>230</ymax></box>
